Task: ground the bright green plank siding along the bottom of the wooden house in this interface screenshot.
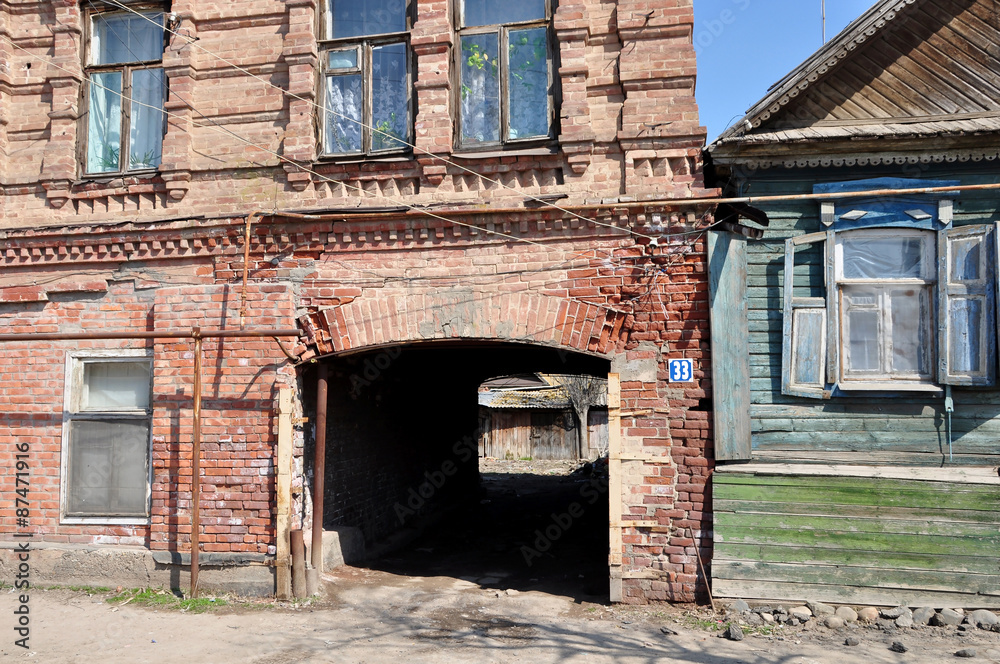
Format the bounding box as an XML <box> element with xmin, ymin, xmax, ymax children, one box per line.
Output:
<box><xmin>712</xmin><ymin>472</ymin><xmax>1000</xmax><ymax>608</ymax></box>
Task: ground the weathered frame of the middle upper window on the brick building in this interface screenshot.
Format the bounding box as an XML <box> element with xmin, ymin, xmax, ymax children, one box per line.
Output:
<box><xmin>319</xmin><ymin>0</ymin><xmax>414</xmax><ymax>159</ymax></box>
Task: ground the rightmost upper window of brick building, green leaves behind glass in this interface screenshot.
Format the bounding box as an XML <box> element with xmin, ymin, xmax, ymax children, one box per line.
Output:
<box><xmin>458</xmin><ymin>0</ymin><xmax>555</xmax><ymax>148</ymax></box>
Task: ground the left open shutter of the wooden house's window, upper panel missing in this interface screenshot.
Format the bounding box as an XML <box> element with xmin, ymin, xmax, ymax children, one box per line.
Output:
<box><xmin>781</xmin><ymin>233</ymin><xmax>830</xmax><ymax>399</ymax></box>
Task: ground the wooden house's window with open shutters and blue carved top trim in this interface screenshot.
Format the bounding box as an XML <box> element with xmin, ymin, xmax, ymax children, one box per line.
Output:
<box><xmin>782</xmin><ymin>179</ymin><xmax>1000</xmax><ymax>398</ymax></box>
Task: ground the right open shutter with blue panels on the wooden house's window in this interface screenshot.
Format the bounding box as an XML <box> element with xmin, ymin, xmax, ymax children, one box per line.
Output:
<box><xmin>938</xmin><ymin>224</ymin><xmax>997</xmax><ymax>386</ymax></box>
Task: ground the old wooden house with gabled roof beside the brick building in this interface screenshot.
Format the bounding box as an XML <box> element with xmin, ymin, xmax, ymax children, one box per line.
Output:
<box><xmin>708</xmin><ymin>0</ymin><xmax>1000</xmax><ymax>607</ymax></box>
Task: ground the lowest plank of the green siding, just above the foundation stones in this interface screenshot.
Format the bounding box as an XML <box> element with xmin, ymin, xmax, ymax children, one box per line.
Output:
<box><xmin>712</xmin><ymin>579</ymin><xmax>1000</xmax><ymax>609</ymax></box>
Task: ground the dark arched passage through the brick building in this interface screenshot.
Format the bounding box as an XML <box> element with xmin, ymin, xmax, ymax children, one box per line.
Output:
<box><xmin>305</xmin><ymin>342</ymin><xmax>609</xmax><ymax>601</ymax></box>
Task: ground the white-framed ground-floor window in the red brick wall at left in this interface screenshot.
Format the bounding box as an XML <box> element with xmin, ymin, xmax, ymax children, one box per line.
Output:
<box><xmin>63</xmin><ymin>351</ymin><xmax>151</xmax><ymax>521</ymax></box>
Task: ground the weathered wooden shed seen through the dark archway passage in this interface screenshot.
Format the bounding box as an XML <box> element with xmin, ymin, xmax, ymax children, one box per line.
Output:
<box><xmin>479</xmin><ymin>373</ymin><xmax>608</xmax><ymax>459</ymax></box>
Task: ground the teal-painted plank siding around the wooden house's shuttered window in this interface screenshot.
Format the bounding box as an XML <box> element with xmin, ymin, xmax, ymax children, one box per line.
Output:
<box><xmin>747</xmin><ymin>167</ymin><xmax>1000</xmax><ymax>465</ymax></box>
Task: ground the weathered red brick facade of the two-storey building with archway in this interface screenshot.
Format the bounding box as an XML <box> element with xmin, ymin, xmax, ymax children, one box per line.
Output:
<box><xmin>0</xmin><ymin>0</ymin><xmax>712</xmax><ymax>602</ymax></box>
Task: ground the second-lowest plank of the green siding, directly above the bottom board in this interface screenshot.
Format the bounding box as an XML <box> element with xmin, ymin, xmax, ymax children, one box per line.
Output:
<box><xmin>712</xmin><ymin>560</ymin><xmax>1000</xmax><ymax>596</ymax></box>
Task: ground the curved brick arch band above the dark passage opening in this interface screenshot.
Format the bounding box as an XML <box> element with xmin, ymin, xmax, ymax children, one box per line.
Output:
<box><xmin>303</xmin><ymin>288</ymin><xmax>627</xmax><ymax>355</ymax></box>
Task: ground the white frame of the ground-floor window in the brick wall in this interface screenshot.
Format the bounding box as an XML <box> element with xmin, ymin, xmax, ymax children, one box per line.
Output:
<box><xmin>59</xmin><ymin>348</ymin><xmax>153</xmax><ymax>526</ymax></box>
